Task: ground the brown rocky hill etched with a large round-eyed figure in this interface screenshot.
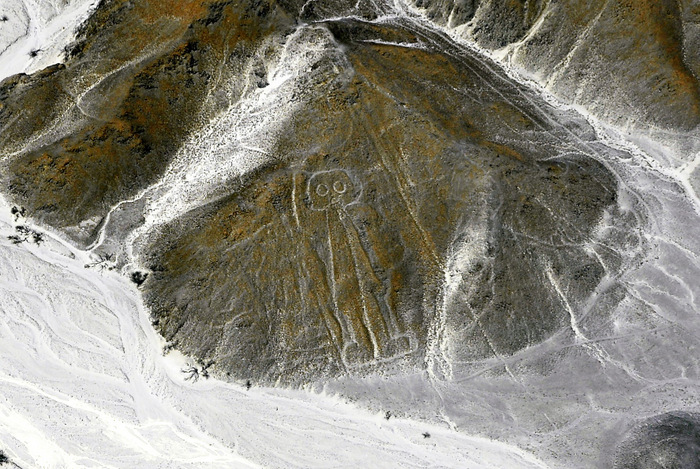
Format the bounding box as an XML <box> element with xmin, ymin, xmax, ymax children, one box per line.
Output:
<box><xmin>139</xmin><ymin>21</ymin><xmax>629</xmax><ymax>382</ymax></box>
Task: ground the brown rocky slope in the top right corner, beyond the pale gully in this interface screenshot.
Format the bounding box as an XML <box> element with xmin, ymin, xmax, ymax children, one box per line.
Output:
<box><xmin>404</xmin><ymin>0</ymin><xmax>700</xmax><ymax>131</ymax></box>
